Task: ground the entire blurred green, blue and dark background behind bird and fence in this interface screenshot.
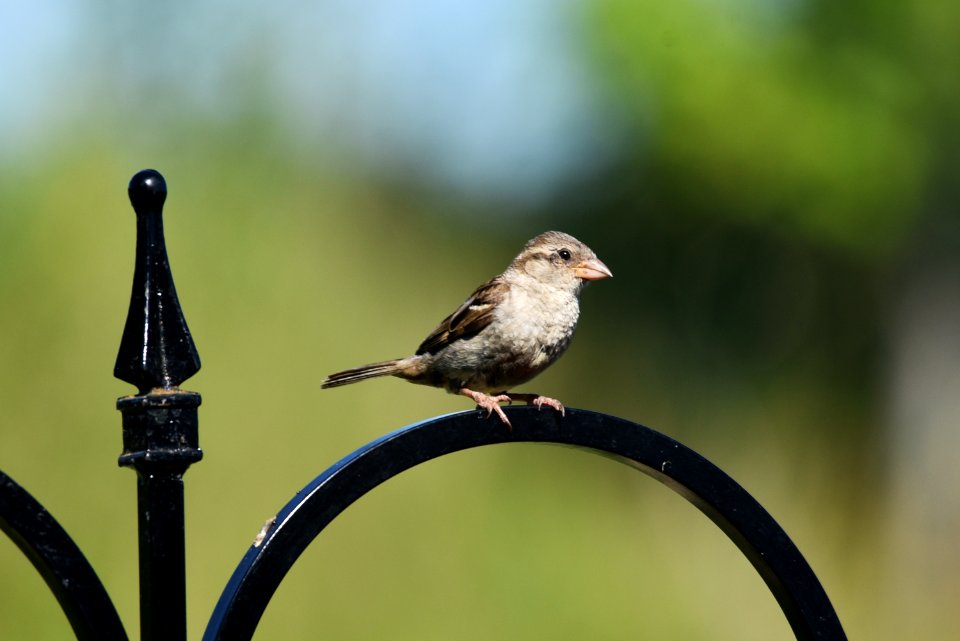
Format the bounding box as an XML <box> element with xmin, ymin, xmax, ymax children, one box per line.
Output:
<box><xmin>0</xmin><ymin>0</ymin><xmax>960</xmax><ymax>640</ymax></box>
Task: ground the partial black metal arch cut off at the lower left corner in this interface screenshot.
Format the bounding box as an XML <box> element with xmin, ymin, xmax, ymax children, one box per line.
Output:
<box><xmin>0</xmin><ymin>472</ymin><xmax>127</xmax><ymax>641</ymax></box>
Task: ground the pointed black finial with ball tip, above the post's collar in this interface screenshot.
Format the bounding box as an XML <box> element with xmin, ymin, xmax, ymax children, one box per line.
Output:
<box><xmin>113</xmin><ymin>169</ymin><xmax>200</xmax><ymax>394</ymax></box>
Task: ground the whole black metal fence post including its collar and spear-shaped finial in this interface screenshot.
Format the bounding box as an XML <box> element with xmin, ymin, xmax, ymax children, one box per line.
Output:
<box><xmin>114</xmin><ymin>169</ymin><xmax>203</xmax><ymax>641</ymax></box>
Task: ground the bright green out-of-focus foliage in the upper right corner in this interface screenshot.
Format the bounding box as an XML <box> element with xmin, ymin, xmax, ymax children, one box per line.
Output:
<box><xmin>595</xmin><ymin>0</ymin><xmax>960</xmax><ymax>256</ymax></box>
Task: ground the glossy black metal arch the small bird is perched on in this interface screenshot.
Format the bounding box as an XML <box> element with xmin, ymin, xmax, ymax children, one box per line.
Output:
<box><xmin>203</xmin><ymin>407</ymin><xmax>846</xmax><ymax>641</ymax></box>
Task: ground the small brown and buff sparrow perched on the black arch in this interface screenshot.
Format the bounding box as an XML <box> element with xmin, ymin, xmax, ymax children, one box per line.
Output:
<box><xmin>321</xmin><ymin>231</ymin><xmax>613</xmax><ymax>426</ymax></box>
